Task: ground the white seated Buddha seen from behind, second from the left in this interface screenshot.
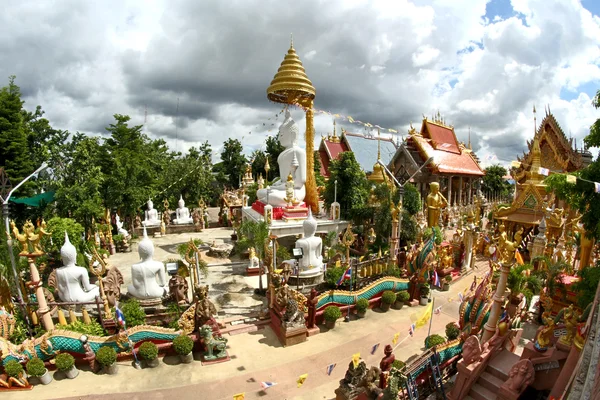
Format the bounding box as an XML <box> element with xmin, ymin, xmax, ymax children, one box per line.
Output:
<box><xmin>127</xmin><ymin>227</ymin><xmax>168</xmax><ymax>300</ymax></box>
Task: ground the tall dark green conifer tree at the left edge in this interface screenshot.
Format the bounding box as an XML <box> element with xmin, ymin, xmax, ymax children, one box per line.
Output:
<box><xmin>0</xmin><ymin>76</ymin><xmax>38</xmax><ymax>196</ymax></box>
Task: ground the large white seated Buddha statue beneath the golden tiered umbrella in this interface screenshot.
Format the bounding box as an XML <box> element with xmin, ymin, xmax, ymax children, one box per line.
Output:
<box><xmin>256</xmin><ymin>110</ymin><xmax>306</xmax><ymax>207</ymax></box>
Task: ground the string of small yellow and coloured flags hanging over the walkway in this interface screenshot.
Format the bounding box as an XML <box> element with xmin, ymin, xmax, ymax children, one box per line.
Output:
<box><xmin>219</xmin><ymin>300</ymin><xmax>450</xmax><ymax>400</ymax></box>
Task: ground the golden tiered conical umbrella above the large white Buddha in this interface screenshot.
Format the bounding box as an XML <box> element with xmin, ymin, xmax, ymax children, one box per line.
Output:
<box><xmin>267</xmin><ymin>38</ymin><xmax>316</xmax><ymax>106</ymax></box>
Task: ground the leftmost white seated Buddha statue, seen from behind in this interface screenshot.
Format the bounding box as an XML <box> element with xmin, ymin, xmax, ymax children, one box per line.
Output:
<box><xmin>56</xmin><ymin>232</ymin><xmax>100</xmax><ymax>302</ymax></box>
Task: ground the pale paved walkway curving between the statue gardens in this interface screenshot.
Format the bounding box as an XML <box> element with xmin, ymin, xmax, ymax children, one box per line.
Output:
<box><xmin>6</xmin><ymin>262</ymin><xmax>487</xmax><ymax>400</ymax></box>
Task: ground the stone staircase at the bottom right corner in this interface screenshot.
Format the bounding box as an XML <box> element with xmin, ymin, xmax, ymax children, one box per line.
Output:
<box><xmin>465</xmin><ymin>349</ymin><xmax>520</xmax><ymax>400</ymax></box>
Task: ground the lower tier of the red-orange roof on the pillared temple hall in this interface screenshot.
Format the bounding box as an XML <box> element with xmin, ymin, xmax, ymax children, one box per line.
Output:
<box><xmin>409</xmin><ymin>135</ymin><xmax>485</xmax><ymax>176</ymax></box>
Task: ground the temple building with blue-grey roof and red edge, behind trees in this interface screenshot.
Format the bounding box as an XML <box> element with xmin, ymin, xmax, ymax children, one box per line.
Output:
<box><xmin>319</xmin><ymin>122</ymin><xmax>398</xmax><ymax>179</ymax></box>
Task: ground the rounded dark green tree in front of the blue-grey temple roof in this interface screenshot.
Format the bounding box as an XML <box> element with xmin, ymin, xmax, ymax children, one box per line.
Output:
<box><xmin>324</xmin><ymin>151</ymin><xmax>370</xmax><ymax>219</ymax></box>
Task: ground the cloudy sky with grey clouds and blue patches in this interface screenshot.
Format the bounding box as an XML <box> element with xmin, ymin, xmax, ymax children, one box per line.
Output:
<box><xmin>0</xmin><ymin>0</ymin><xmax>600</xmax><ymax>164</ymax></box>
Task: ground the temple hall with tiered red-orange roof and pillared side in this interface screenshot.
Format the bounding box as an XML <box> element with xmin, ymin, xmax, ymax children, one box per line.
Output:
<box><xmin>383</xmin><ymin>113</ymin><xmax>484</xmax><ymax>205</ymax></box>
